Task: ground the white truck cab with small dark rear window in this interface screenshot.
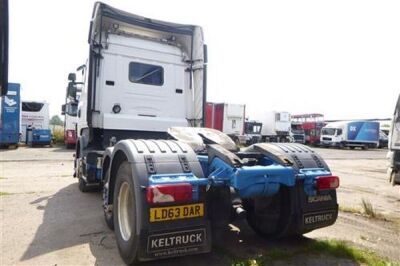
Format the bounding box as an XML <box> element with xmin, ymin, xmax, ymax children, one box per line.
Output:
<box><xmin>71</xmin><ymin>3</ymin><xmax>206</xmax><ymax>150</ymax></box>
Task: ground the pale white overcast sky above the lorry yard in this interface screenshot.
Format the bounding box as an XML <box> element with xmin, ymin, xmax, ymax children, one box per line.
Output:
<box><xmin>9</xmin><ymin>0</ymin><xmax>400</xmax><ymax>119</ymax></box>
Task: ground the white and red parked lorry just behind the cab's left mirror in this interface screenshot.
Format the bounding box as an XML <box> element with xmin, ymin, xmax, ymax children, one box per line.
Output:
<box><xmin>61</xmin><ymin>101</ymin><xmax>78</xmax><ymax>149</ymax></box>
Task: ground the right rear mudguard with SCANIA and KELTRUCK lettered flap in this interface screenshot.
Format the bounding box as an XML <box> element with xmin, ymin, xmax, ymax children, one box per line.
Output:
<box><xmin>249</xmin><ymin>143</ymin><xmax>338</xmax><ymax>234</ymax></box>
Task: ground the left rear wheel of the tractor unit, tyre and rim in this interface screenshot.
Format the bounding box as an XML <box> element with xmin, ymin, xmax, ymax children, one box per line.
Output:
<box><xmin>113</xmin><ymin>161</ymin><xmax>139</xmax><ymax>265</ymax></box>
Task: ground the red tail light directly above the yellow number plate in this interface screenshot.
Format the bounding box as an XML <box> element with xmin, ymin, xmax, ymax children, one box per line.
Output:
<box><xmin>146</xmin><ymin>183</ymin><xmax>193</xmax><ymax>204</ymax></box>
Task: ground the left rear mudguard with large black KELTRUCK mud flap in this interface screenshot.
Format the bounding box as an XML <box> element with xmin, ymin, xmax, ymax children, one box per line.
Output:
<box><xmin>104</xmin><ymin>140</ymin><xmax>211</xmax><ymax>261</ymax></box>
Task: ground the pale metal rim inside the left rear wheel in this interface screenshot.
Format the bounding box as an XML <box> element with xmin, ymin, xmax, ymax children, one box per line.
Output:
<box><xmin>118</xmin><ymin>182</ymin><xmax>133</xmax><ymax>241</ymax></box>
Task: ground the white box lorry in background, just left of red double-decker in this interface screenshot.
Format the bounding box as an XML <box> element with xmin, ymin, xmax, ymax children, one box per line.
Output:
<box><xmin>256</xmin><ymin>111</ymin><xmax>291</xmax><ymax>142</ymax></box>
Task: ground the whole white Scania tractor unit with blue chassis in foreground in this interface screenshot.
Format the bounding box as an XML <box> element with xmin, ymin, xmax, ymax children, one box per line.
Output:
<box><xmin>67</xmin><ymin>3</ymin><xmax>339</xmax><ymax>264</ymax></box>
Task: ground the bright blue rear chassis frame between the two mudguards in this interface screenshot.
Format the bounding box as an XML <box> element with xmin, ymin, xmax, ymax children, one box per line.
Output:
<box><xmin>149</xmin><ymin>156</ymin><xmax>331</xmax><ymax>200</ymax></box>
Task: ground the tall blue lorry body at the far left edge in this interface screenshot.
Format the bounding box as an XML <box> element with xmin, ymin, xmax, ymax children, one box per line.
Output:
<box><xmin>0</xmin><ymin>83</ymin><xmax>21</xmax><ymax>148</ymax></box>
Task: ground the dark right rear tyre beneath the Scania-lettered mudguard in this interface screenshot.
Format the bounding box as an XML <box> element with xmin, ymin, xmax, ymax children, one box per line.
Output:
<box><xmin>245</xmin><ymin>188</ymin><xmax>291</xmax><ymax>239</ymax></box>
